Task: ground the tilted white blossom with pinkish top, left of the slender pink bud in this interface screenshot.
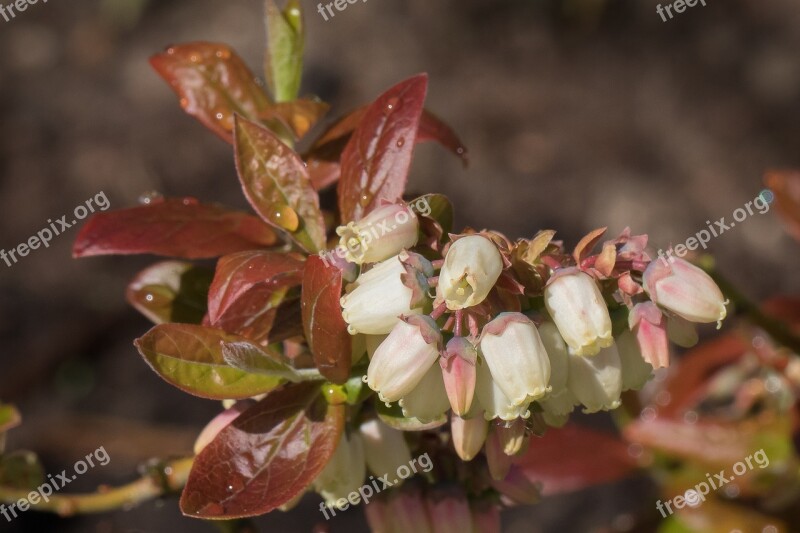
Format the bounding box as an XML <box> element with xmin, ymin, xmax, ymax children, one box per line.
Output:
<box><xmin>366</xmin><ymin>315</ymin><xmax>446</xmax><ymax>402</ymax></box>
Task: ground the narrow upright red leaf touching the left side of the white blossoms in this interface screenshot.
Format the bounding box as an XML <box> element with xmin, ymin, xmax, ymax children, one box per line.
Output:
<box><xmin>302</xmin><ymin>255</ymin><xmax>352</xmax><ymax>383</ymax></box>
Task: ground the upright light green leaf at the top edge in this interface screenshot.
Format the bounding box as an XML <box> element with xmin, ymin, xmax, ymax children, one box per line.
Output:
<box><xmin>265</xmin><ymin>0</ymin><xmax>305</xmax><ymax>102</ymax></box>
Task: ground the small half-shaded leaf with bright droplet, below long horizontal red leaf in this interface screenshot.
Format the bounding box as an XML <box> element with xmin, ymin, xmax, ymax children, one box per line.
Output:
<box><xmin>125</xmin><ymin>261</ymin><xmax>214</xmax><ymax>324</ymax></box>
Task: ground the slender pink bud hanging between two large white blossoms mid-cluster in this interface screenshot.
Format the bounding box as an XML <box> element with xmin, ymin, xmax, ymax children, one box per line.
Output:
<box><xmin>439</xmin><ymin>337</ymin><xmax>478</xmax><ymax>416</ymax></box>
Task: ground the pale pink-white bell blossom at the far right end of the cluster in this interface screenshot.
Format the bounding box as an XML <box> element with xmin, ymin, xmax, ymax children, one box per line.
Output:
<box><xmin>643</xmin><ymin>258</ymin><xmax>727</xmax><ymax>323</ymax></box>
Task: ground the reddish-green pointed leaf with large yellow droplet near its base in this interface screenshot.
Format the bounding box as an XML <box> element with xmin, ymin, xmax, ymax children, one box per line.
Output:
<box><xmin>234</xmin><ymin>117</ymin><xmax>325</xmax><ymax>253</ymax></box>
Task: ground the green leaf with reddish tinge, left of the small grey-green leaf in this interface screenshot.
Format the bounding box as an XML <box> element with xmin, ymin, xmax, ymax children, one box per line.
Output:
<box><xmin>134</xmin><ymin>324</ymin><xmax>281</xmax><ymax>400</ymax></box>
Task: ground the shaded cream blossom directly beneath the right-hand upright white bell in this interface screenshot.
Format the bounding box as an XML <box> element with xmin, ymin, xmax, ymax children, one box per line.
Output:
<box><xmin>568</xmin><ymin>344</ymin><xmax>622</xmax><ymax>413</ymax></box>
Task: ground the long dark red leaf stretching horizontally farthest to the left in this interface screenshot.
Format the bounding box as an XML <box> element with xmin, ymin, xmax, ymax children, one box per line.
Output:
<box><xmin>72</xmin><ymin>198</ymin><xmax>277</xmax><ymax>259</ymax></box>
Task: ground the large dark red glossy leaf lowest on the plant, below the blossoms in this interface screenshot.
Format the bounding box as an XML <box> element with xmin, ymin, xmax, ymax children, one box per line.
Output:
<box><xmin>181</xmin><ymin>383</ymin><xmax>344</xmax><ymax>519</ymax></box>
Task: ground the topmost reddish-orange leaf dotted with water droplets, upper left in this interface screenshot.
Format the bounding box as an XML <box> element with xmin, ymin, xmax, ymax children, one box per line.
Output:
<box><xmin>150</xmin><ymin>42</ymin><xmax>272</xmax><ymax>143</ymax></box>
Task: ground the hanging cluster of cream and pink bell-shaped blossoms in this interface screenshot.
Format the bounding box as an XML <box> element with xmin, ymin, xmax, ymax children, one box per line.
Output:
<box><xmin>339</xmin><ymin>206</ymin><xmax>726</xmax><ymax>468</ymax></box>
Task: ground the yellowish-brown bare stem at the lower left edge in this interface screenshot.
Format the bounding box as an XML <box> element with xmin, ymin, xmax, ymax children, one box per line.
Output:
<box><xmin>0</xmin><ymin>458</ymin><xmax>194</xmax><ymax>516</ymax></box>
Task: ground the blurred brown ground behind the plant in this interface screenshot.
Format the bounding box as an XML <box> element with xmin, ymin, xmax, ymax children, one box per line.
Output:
<box><xmin>0</xmin><ymin>0</ymin><xmax>800</xmax><ymax>532</ymax></box>
